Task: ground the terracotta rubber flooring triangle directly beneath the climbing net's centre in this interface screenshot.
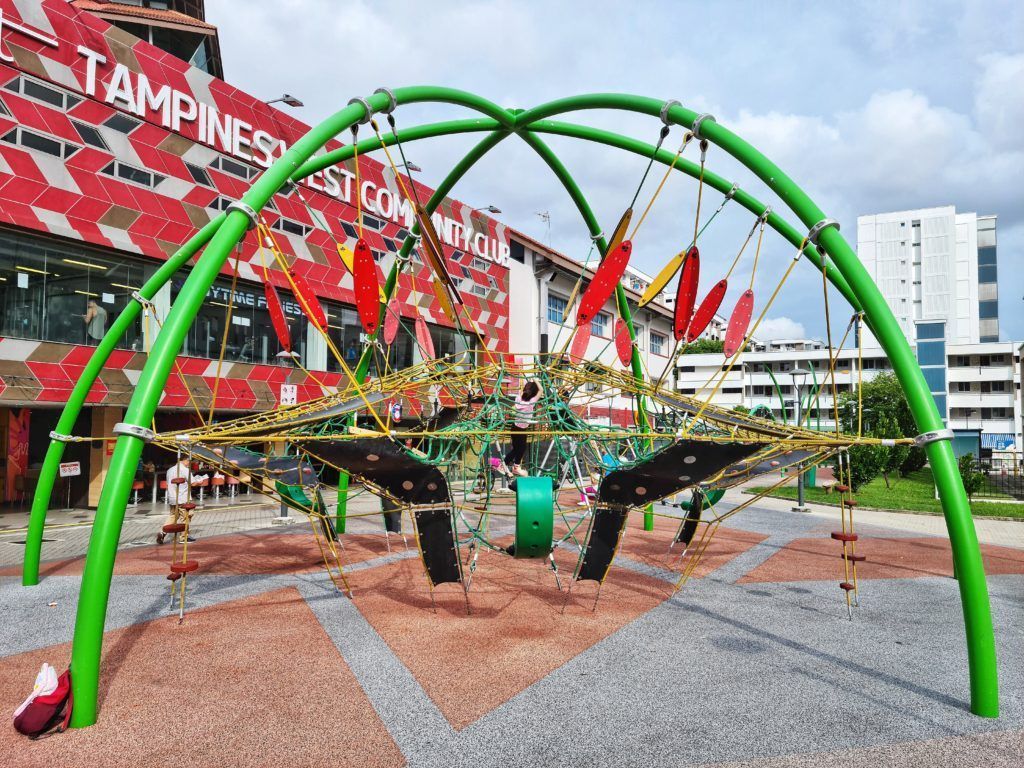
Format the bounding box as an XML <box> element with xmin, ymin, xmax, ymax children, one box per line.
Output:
<box><xmin>355</xmin><ymin>551</ymin><xmax>669</xmax><ymax>729</ymax></box>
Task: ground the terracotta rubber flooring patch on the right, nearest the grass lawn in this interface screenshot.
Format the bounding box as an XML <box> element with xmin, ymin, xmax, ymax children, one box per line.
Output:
<box><xmin>739</xmin><ymin>536</ymin><xmax>1024</xmax><ymax>583</ymax></box>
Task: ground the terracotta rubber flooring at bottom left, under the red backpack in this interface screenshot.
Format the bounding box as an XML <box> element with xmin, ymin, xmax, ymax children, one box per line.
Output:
<box><xmin>0</xmin><ymin>585</ymin><xmax>404</xmax><ymax>768</ymax></box>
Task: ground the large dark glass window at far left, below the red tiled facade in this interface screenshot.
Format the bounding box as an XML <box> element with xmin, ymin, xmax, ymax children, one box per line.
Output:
<box><xmin>0</xmin><ymin>230</ymin><xmax>156</xmax><ymax>349</ymax></box>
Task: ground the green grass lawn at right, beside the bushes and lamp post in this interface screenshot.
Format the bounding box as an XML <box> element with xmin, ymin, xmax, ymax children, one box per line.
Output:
<box><xmin>751</xmin><ymin>467</ymin><xmax>1024</xmax><ymax>520</ymax></box>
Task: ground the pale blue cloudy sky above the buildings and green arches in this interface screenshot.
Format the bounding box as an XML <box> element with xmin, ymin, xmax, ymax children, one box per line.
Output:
<box><xmin>207</xmin><ymin>0</ymin><xmax>1024</xmax><ymax>340</ymax></box>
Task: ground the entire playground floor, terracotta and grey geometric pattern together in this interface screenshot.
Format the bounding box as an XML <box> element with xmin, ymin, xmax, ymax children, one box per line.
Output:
<box><xmin>0</xmin><ymin>495</ymin><xmax>1024</xmax><ymax>768</ymax></box>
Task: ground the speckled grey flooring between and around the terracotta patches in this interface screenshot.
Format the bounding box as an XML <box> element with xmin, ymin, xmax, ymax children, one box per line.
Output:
<box><xmin>0</xmin><ymin>489</ymin><xmax>1024</xmax><ymax>768</ymax></box>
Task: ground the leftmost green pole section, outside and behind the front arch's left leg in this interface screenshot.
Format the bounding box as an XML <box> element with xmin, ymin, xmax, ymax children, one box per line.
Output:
<box><xmin>22</xmin><ymin>213</ymin><xmax>224</xmax><ymax>587</ymax></box>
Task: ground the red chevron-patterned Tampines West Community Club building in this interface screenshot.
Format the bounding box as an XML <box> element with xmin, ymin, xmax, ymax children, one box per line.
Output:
<box><xmin>0</xmin><ymin>0</ymin><xmax>510</xmax><ymax>506</ymax></box>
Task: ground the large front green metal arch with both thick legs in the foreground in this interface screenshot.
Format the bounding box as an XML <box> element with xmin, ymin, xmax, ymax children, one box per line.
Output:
<box><xmin>28</xmin><ymin>86</ymin><xmax>998</xmax><ymax>727</ymax></box>
